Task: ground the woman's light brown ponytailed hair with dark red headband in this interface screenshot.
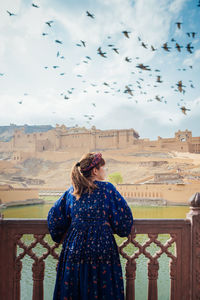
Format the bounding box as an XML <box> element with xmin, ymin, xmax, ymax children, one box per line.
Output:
<box><xmin>71</xmin><ymin>152</ymin><xmax>105</xmax><ymax>200</ymax></box>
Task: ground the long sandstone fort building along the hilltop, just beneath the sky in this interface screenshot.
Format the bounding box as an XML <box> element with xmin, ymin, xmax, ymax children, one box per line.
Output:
<box><xmin>0</xmin><ymin>125</ymin><xmax>200</xmax><ymax>161</ymax></box>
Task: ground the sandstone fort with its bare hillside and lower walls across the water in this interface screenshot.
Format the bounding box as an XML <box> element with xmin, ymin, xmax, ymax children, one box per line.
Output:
<box><xmin>0</xmin><ymin>125</ymin><xmax>200</xmax><ymax>205</ymax></box>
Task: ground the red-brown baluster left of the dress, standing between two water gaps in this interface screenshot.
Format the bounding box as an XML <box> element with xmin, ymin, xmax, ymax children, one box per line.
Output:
<box><xmin>32</xmin><ymin>260</ymin><xmax>45</xmax><ymax>300</ymax></box>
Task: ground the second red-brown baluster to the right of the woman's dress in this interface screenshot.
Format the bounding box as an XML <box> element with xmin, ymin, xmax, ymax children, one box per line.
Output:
<box><xmin>148</xmin><ymin>260</ymin><xmax>159</xmax><ymax>300</ymax></box>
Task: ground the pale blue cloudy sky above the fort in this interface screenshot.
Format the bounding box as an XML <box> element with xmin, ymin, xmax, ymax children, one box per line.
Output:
<box><xmin>0</xmin><ymin>0</ymin><xmax>200</xmax><ymax>139</ymax></box>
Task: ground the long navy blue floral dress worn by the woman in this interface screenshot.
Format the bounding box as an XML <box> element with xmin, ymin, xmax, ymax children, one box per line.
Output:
<box><xmin>47</xmin><ymin>180</ymin><xmax>133</xmax><ymax>300</ymax></box>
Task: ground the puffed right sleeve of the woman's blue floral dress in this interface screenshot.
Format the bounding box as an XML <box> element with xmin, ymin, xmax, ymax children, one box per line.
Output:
<box><xmin>108</xmin><ymin>184</ymin><xmax>133</xmax><ymax>237</ymax></box>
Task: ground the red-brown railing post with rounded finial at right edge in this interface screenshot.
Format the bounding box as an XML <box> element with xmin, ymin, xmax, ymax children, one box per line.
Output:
<box><xmin>187</xmin><ymin>193</ymin><xmax>200</xmax><ymax>300</ymax></box>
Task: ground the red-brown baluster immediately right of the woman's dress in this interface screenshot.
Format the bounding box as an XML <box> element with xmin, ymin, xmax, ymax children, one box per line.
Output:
<box><xmin>126</xmin><ymin>260</ymin><xmax>136</xmax><ymax>300</ymax></box>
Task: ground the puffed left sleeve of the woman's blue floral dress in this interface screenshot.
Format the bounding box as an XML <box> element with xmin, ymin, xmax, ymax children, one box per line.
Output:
<box><xmin>47</xmin><ymin>190</ymin><xmax>71</xmax><ymax>243</ymax></box>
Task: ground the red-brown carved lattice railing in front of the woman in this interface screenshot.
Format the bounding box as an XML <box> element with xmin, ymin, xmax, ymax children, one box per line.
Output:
<box><xmin>0</xmin><ymin>193</ymin><xmax>200</xmax><ymax>300</ymax></box>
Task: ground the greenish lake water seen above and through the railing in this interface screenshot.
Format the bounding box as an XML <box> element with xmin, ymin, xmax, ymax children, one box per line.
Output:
<box><xmin>3</xmin><ymin>202</ymin><xmax>189</xmax><ymax>300</ymax></box>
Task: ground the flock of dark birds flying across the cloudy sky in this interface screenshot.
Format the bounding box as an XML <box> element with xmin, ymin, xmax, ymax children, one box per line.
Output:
<box><xmin>0</xmin><ymin>0</ymin><xmax>200</xmax><ymax>123</ymax></box>
